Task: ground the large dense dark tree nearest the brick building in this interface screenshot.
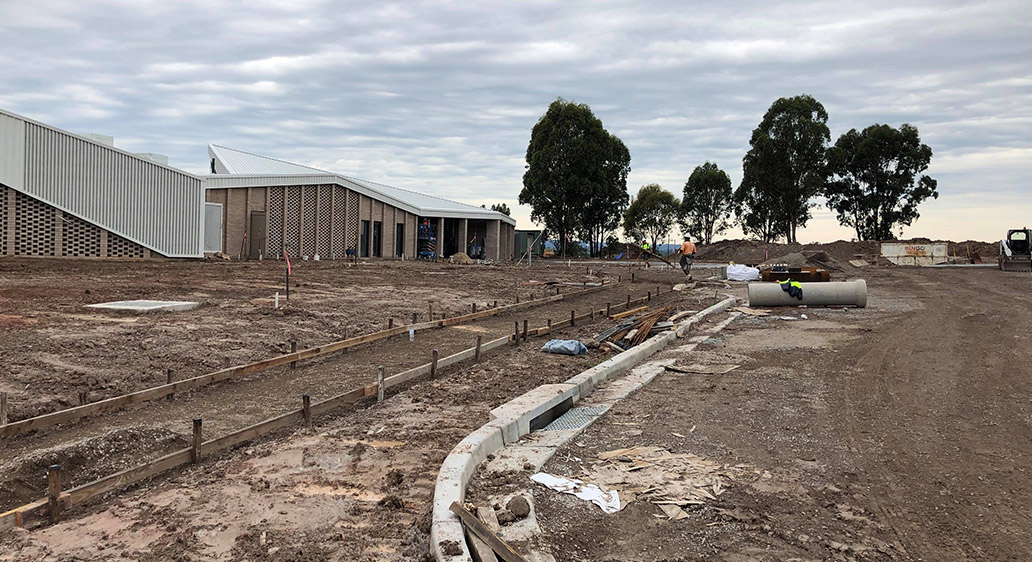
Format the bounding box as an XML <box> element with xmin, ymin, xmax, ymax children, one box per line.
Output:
<box><xmin>519</xmin><ymin>98</ymin><xmax>631</xmax><ymax>255</ymax></box>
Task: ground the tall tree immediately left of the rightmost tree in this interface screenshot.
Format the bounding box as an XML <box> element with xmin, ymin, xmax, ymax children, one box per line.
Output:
<box><xmin>735</xmin><ymin>94</ymin><xmax>831</xmax><ymax>242</ymax></box>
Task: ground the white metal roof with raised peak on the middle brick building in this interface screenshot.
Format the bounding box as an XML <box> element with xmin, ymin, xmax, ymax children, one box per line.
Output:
<box><xmin>204</xmin><ymin>144</ymin><xmax>516</xmax><ymax>226</ymax></box>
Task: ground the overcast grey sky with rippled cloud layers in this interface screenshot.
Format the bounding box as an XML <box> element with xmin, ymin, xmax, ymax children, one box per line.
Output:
<box><xmin>0</xmin><ymin>0</ymin><xmax>1032</xmax><ymax>241</ymax></box>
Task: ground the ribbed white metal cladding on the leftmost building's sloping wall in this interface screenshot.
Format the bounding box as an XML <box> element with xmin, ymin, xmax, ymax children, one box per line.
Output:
<box><xmin>18</xmin><ymin>122</ymin><xmax>204</xmax><ymax>258</ymax></box>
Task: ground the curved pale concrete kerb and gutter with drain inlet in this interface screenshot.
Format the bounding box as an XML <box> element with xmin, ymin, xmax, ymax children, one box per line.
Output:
<box><xmin>430</xmin><ymin>297</ymin><xmax>739</xmax><ymax>562</ymax></box>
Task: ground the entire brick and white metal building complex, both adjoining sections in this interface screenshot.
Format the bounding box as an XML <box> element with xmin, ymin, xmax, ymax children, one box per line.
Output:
<box><xmin>0</xmin><ymin>109</ymin><xmax>515</xmax><ymax>260</ymax></box>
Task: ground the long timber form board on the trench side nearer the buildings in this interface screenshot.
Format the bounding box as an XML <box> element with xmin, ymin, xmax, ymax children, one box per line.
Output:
<box><xmin>0</xmin><ymin>284</ymin><xmax>615</xmax><ymax>438</ymax></box>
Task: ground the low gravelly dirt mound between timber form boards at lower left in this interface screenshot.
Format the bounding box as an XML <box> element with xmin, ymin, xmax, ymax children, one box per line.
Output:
<box><xmin>0</xmin><ymin>427</ymin><xmax>189</xmax><ymax>511</ymax></box>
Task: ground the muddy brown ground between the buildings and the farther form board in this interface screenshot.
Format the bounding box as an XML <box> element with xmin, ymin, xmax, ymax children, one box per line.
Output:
<box><xmin>0</xmin><ymin>259</ymin><xmax>626</xmax><ymax>421</ymax></box>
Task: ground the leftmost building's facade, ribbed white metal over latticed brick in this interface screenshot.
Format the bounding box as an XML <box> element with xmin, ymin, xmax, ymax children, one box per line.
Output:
<box><xmin>0</xmin><ymin>110</ymin><xmax>204</xmax><ymax>258</ymax></box>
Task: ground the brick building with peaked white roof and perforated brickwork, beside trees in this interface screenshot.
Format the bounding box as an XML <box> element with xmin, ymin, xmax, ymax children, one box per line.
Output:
<box><xmin>204</xmin><ymin>144</ymin><xmax>516</xmax><ymax>261</ymax></box>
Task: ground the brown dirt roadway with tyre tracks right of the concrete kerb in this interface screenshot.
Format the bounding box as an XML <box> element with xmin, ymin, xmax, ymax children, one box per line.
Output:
<box><xmin>480</xmin><ymin>268</ymin><xmax>1032</xmax><ymax>562</ymax></box>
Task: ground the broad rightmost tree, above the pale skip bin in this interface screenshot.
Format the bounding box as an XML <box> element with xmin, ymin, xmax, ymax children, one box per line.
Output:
<box><xmin>826</xmin><ymin>123</ymin><xmax>939</xmax><ymax>240</ymax></box>
